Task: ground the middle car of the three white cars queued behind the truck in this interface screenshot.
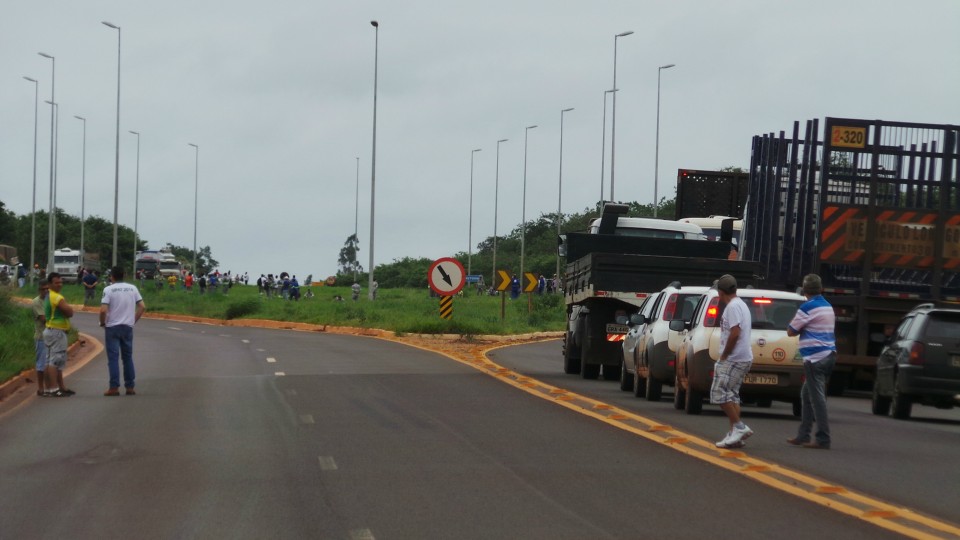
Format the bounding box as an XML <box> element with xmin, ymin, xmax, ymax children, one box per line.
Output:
<box><xmin>632</xmin><ymin>281</ymin><xmax>709</xmax><ymax>401</ymax></box>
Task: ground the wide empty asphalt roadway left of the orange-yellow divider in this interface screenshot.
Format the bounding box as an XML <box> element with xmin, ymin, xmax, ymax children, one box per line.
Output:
<box><xmin>0</xmin><ymin>314</ymin><xmax>894</xmax><ymax>539</ymax></box>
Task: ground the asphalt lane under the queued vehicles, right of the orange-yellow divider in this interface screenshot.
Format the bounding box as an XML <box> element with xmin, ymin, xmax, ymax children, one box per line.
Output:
<box><xmin>490</xmin><ymin>340</ymin><xmax>960</xmax><ymax>523</ymax></box>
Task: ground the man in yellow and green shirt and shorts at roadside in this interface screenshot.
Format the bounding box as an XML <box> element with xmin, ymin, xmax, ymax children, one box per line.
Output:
<box><xmin>43</xmin><ymin>272</ymin><xmax>74</xmax><ymax>397</ymax></box>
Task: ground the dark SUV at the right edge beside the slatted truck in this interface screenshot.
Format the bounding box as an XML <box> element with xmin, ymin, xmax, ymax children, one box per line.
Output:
<box><xmin>873</xmin><ymin>304</ymin><xmax>960</xmax><ymax>419</ymax></box>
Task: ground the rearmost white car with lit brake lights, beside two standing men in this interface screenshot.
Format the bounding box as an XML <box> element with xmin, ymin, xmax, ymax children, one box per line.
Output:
<box><xmin>670</xmin><ymin>288</ymin><xmax>806</xmax><ymax>416</ymax></box>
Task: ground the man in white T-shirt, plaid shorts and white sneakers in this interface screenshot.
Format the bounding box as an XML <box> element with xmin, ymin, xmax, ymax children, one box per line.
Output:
<box><xmin>710</xmin><ymin>274</ymin><xmax>753</xmax><ymax>448</ymax></box>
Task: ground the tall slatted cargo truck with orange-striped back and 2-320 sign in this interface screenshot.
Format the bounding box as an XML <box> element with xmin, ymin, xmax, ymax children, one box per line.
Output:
<box><xmin>740</xmin><ymin>117</ymin><xmax>960</xmax><ymax>395</ymax></box>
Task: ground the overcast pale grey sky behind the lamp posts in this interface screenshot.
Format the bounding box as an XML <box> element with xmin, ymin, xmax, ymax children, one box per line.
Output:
<box><xmin>0</xmin><ymin>0</ymin><xmax>960</xmax><ymax>278</ymax></box>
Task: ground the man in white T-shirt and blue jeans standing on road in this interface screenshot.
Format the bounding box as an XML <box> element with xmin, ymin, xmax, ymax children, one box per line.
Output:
<box><xmin>100</xmin><ymin>266</ymin><xmax>147</xmax><ymax>396</ymax></box>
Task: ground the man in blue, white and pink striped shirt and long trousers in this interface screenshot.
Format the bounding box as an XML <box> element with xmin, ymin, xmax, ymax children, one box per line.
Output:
<box><xmin>787</xmin><ymin>274</ymin><xmax>837</xmax><ymax>450</ymax></box>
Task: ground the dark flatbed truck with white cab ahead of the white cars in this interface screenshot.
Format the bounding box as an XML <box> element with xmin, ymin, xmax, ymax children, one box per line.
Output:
<box><xmin>559</xmin><ymin>203</ymin><xmax>755</xmax><ymax>379</ymax></box>
